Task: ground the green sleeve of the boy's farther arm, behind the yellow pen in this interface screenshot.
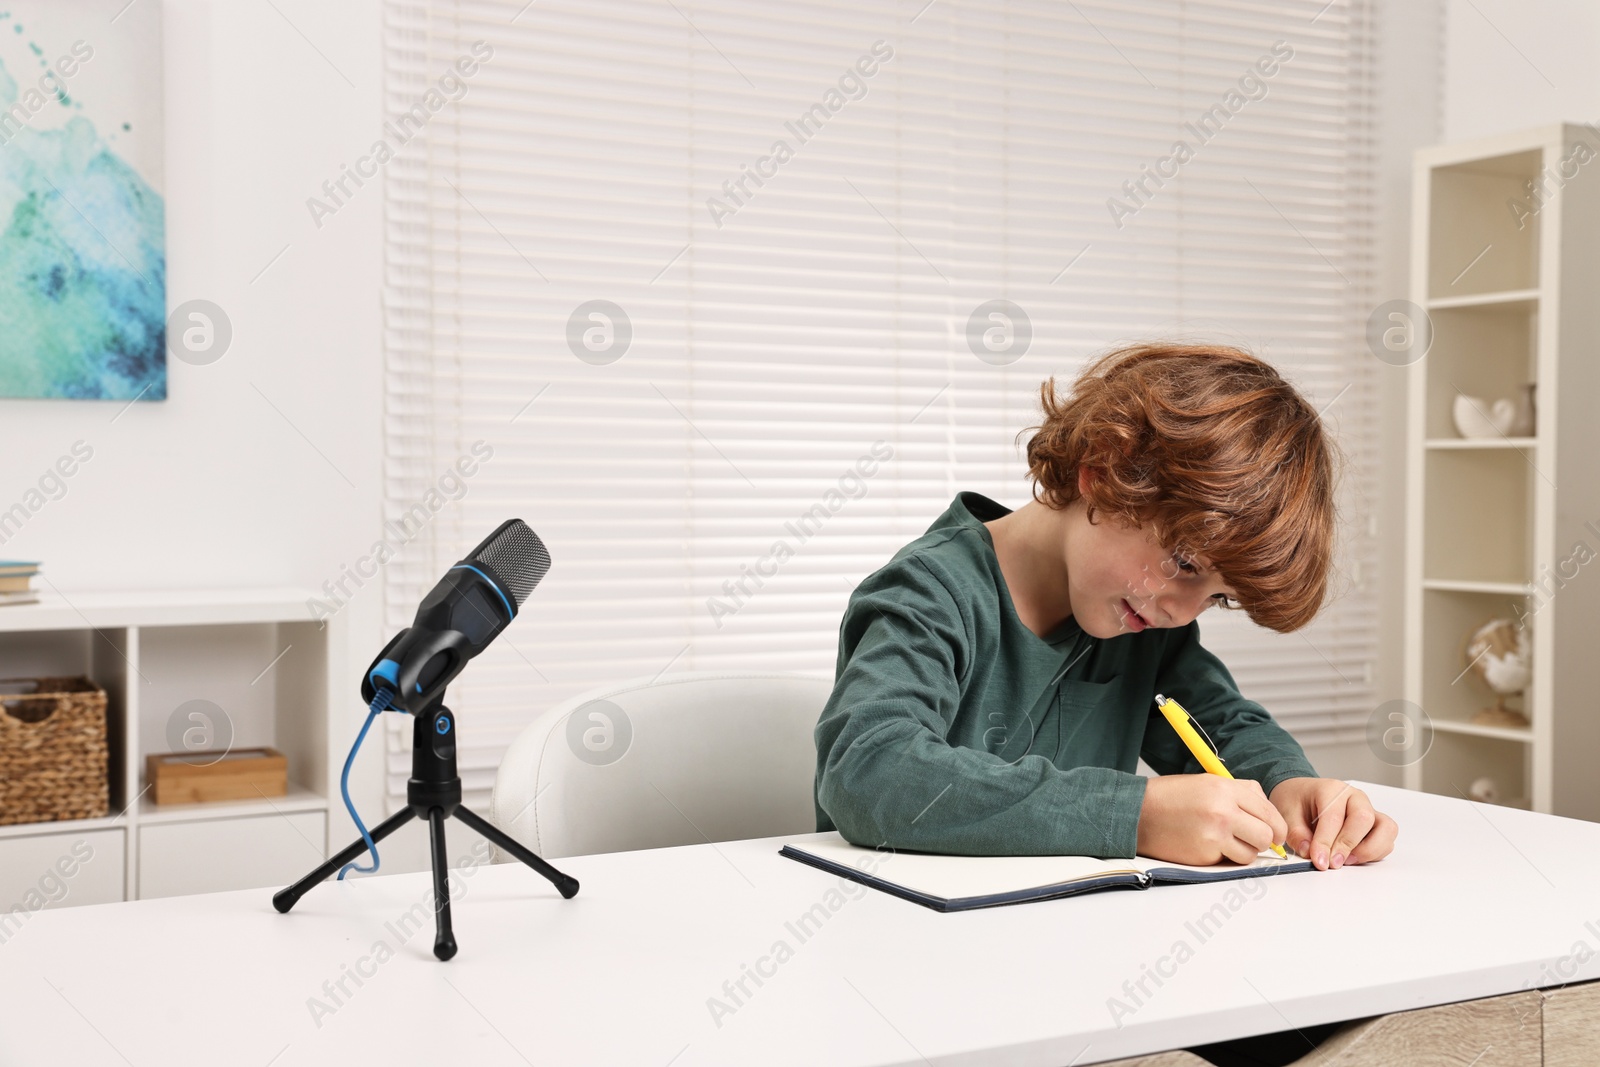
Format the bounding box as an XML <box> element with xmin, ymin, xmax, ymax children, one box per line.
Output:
<box><xmin>1141</xmin><ymin>621</ymin><xmax>1317</xmax><ymax>797</ymax></box>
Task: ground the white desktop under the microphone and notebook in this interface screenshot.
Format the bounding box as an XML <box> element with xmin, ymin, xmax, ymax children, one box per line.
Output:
<box><xmin>0</xmin><ymin>782</ymin><xmax>1600</xmax><ymax>1067</ymax></box>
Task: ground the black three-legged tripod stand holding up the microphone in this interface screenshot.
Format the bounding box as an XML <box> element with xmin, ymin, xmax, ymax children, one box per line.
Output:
<box><xmin>272</xmin><ymin>693</ymin><xmax>578</xmax><ymax>960</ymax></box>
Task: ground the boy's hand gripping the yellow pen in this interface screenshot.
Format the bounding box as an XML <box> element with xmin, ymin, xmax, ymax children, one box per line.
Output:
<box><xmin>1138</xmin><ymin>774</ymin><xmax>1288</xmax><ymax>867</ymax></box>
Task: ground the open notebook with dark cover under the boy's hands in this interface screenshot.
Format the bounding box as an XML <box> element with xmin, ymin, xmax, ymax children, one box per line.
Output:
<box><xmin>778</xmin><ymin>830</ymin><xmax>1314</xmax><ymax>912</ymax></box>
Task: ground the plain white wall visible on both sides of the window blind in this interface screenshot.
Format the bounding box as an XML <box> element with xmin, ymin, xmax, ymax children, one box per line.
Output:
<box><xmin>0</xmin><ymin>0</ymin><xmax>1510</xmax><ymax>870</ymax></box>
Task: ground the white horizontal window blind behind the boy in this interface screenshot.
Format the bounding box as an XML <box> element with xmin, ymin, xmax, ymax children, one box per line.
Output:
<box><xmin>380</xmin><ymin>0</ymin><xmax>1376</xmax><ymax>803</ymax></box>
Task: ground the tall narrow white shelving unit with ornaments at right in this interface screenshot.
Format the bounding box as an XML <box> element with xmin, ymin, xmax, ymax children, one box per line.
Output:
<box><xmin>1405</xmin><ymin>125</ymin><xmax>1600</xmax><ymax>819</ymax></box>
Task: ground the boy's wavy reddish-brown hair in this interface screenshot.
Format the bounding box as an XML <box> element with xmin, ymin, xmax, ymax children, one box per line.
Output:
<box><xmin>1024</xmin><ymin>342</ymin><xmax>1336</xmax><ymax>633</ymax></box>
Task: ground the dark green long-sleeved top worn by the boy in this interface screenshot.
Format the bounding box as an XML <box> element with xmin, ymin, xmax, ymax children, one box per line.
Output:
<box><xmin>814</xmin><ymin>493</ymin><xmax>1317</xmax><ymax>859</ymax></box>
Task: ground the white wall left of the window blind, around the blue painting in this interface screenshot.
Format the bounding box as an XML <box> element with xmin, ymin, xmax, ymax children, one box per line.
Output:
<box><xmin>0</xmin><ymin>0</ymin><xmax>475</xmax><ymax>870</ymax></box>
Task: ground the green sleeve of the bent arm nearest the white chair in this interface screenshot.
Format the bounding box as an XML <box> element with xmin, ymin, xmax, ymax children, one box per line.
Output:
<box><xmin>814</xmin><ymin>557</ymin><xmax>1144</xmax><ymax>859</ymax></box>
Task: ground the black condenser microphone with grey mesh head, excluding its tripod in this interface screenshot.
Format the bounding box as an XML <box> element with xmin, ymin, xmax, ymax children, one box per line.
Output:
<box><xmin>362</xmin><ymin>518</ymin><xmax>550</xmax><ymax>715</ymax></box>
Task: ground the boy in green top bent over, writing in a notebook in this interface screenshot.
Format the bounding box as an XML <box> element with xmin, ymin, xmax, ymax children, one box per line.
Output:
<box><xmin>814</xmin><ymin>344</ymin><xmax>1398</xmax><ymax>870</ymax></box>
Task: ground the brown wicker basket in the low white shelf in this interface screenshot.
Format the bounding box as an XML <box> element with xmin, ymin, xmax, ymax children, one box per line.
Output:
<box><xmin>0</xmin><ymin>677</ymin><xmax>110</xmax><ymax>825</ymax></box>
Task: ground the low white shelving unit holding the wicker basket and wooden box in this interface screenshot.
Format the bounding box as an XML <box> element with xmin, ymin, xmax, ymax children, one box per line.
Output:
<box><xmin>0</xmin><ymin>589</ymin><xmax>344</xmax><ymax>915</ymax></box>
